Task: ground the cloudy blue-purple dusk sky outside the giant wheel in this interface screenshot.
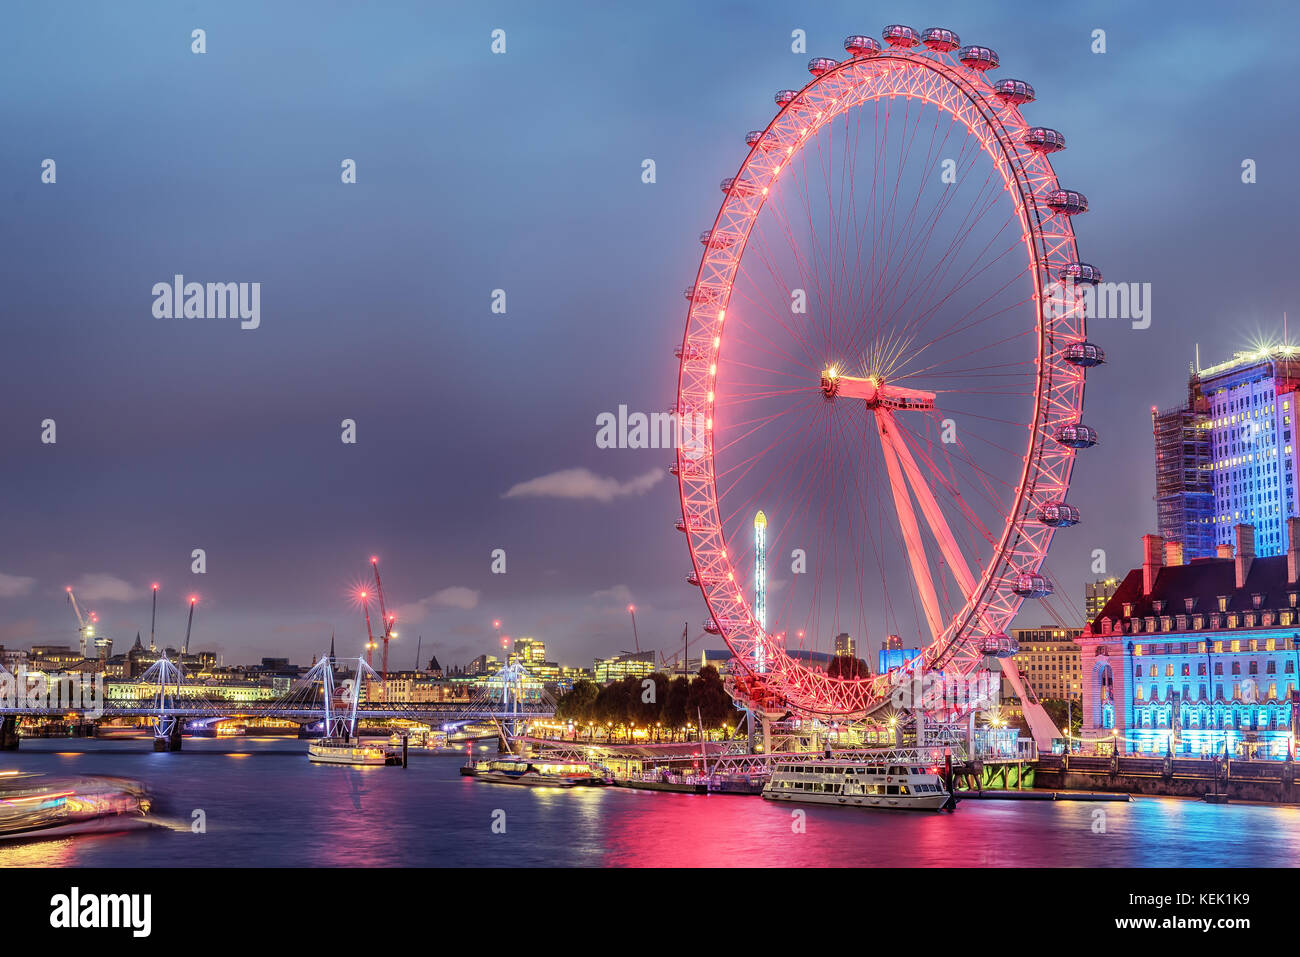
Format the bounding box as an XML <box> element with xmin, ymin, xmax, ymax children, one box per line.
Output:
<box><xmin>0</xmin><ymin>1</ymin><xmax>1300</xmax><ymax>667</ymax></box>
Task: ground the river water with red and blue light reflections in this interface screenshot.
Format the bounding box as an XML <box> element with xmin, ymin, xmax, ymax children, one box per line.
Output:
<box><xmin>0</xmin><ymin>739</ymin><xmax>1300</xmax><ymax>867</ymax></box>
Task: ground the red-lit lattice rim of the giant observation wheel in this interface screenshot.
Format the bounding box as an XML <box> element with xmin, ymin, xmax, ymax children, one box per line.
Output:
<box><xmin>675</xmin><ymin>41</ymin><xmax>1084</xmax><ymax>715</ymax></box>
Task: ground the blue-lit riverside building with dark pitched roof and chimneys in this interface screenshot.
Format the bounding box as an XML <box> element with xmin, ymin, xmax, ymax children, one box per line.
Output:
<box><xmin>1079</xmin><ymin>518</ymin><xmax>1300</xmax><ymax>758</ymax></box>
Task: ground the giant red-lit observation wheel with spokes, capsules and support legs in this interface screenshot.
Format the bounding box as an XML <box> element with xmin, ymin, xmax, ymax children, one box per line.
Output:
<box><xmin>673</xmin><ymin>25</ymin><xmax>1105</xmax><ymax>716</ymax></box>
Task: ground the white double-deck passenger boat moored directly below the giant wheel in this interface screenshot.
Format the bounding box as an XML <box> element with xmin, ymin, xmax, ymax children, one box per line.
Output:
<box><xmin>763</xmin><ymin>755</ymin><xmax>949</xmax><ymax>811</ymax></box>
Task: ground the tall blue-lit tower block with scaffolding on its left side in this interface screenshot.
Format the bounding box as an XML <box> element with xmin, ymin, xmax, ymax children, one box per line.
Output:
<box><xmin>1152</xmin><ymin>346</ymin><xmax>1300</xmax><ymax>560</ymax></box>
